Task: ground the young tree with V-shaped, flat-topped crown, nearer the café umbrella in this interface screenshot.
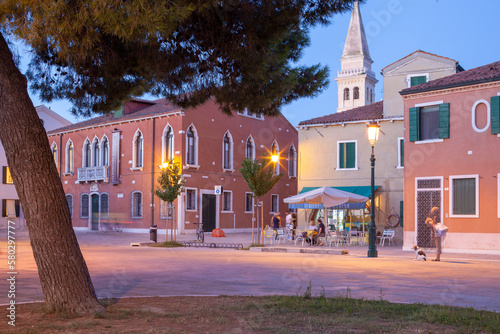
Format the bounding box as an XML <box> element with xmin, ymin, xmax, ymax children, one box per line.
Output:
<box><xmin>239</xmin><ymin>158</ymin><xmax>283</xmax><ymax>242</ymax></box>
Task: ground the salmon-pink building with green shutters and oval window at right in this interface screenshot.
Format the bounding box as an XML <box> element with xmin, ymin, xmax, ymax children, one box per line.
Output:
<box><xmin>401</xmin><ymin>62</ymin><xmax>500</xmax><ymax>254</ymax></box>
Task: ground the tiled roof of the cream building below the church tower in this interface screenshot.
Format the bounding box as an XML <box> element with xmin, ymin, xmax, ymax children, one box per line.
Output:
<box><xmin>299</xmin><ymin>101</ymin><xmax>384</xmax><ymax>126</ymax></box>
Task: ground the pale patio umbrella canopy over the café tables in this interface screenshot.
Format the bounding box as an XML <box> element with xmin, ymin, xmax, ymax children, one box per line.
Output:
<box><xmin>283</xmin><ymin>187</ymin><xmax>368</xmax><ymax>208</ymax></box>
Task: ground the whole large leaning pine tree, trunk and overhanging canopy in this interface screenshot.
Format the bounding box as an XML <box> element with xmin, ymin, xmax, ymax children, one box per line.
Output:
<box><xmin>0</xmin><ymin>0</ymin><xmax>360</xmax><ymax>312</ymax></box>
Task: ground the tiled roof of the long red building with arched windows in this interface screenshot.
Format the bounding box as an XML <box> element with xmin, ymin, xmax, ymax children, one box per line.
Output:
<box><xmin>47</xmin><ymin>99</ymin><xmax>182</xmax><ymax>135</ymax></box>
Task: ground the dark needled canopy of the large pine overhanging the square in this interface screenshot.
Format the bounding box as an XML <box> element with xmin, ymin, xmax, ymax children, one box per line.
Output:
<box><xmin>0</xmin><ymin>0</ymin><xmax>360</xmax><ymax>116</ymax></box>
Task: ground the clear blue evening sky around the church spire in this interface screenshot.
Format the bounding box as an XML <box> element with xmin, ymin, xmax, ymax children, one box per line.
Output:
<box><xmin>26</xmin><ymin>0</ymin><xmax>500</xmax><ymax>125</ymax></box>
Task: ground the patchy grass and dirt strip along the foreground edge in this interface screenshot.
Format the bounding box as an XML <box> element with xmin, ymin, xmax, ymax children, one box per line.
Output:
<box><xmin>9</xmin><ymin>291</ymin><xmax>500</xmax><ymax>334</ymax></box>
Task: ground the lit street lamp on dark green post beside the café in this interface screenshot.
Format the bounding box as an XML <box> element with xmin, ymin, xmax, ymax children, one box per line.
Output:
<box><xmin>367</xmin><ymin>122</ymin><xmax>380</xmax><ymax>257</ymax></box>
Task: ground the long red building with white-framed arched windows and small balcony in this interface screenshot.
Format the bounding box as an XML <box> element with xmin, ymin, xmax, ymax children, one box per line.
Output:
<box><xmin>48</xmin><ymin>99</ymin><xmax>297</xmax><ymax>233</ymax></box>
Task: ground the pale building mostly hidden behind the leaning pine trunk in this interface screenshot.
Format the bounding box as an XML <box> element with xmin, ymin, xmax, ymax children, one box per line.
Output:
<box><xmin>0</xmin><ymin>106</ymin><xmax>71</xmax><ymax>228</ymax></box>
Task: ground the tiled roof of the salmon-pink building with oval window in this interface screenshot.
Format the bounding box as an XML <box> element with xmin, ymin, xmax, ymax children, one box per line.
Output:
<box><xmin>400</xmin><ymin>61</ymin><xmax>500</xmax><ymax>95</ymax></box>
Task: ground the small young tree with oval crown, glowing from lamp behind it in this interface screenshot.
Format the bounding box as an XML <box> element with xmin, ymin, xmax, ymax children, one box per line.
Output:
<box><xmin>155</xmin><ymin>159</ymin><xmax>186</xmax><ymax>241</ymax></box>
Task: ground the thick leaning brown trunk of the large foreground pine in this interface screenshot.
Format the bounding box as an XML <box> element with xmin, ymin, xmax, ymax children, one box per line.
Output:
<box><xmin>0</xmin><ymin>34</ymin><xmax>103</xmax><ymax>313</ymax></box>
